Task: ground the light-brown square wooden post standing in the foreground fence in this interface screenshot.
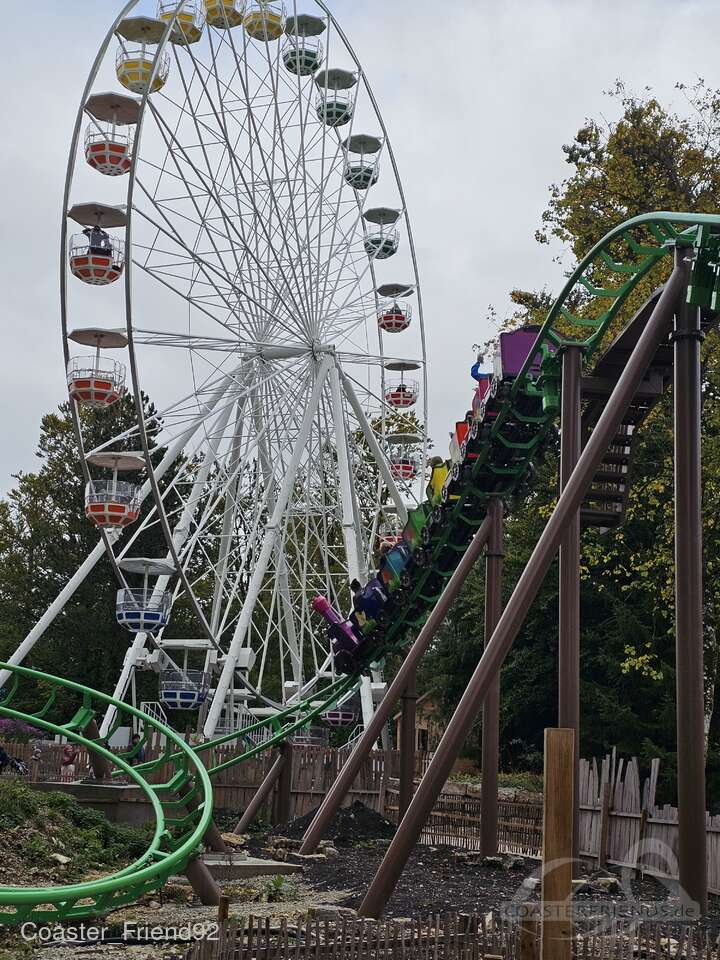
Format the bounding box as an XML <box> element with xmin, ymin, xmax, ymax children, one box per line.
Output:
<box><xmin>542</xmin><ymin>728</ymin><xmax>575</xmax><ymax>960</ymax></box>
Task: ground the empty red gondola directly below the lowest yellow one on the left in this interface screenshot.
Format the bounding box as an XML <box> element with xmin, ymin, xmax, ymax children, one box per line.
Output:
<box><xmin>85</xmin><ymin>93</ymin><xmax>140</xmax><ymax>177</ymax></box>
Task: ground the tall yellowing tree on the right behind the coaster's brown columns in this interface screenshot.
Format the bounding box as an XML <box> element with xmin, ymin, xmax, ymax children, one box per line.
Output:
<box><xmin>416</xmin><ymin>81</ymin><xmax>720</xmax><ymax>799</ymax></box>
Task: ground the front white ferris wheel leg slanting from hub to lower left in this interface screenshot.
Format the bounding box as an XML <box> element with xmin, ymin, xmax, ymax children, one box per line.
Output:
<box><xmin>203</xmin><ymin>355</ymin><xmax>332</xmax><ymax>739</ymax></box>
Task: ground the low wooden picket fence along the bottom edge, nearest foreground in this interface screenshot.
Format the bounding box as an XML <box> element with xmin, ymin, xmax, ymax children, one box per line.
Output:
<box><xmin>185</xmin><ymin>915</ymin><xmax>720</xmax><ymax>960</ymax></box>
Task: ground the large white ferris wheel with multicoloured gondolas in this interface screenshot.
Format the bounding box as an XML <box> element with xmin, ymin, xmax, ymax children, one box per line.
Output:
<box><xmin>28</xmin><ymin>0</ymin><xmax>427</xmax><ymax>737</ymax></box>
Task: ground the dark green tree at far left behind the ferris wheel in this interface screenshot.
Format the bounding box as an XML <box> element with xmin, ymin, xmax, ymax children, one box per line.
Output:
<box><xmin>0</xmin><ymin>395</ymin><xmax>174</xmax><ymax>712</ymax></box>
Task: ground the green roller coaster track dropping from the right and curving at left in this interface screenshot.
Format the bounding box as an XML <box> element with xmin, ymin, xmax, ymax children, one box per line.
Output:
<box><xmin>0</xmin><ymin>213</ymin><xmax>720</xmax><ymax>926</ymax></box>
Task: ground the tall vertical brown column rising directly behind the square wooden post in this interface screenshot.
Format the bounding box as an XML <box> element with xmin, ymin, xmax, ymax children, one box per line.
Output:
<box><xmin>558</xmin><ymin>347</ymin><xmax>583</xmax><ymax>873</ymax></box>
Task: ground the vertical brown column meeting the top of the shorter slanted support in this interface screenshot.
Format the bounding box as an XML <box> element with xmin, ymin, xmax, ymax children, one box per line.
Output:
<box><xmin>480</xmin><ymin>497</ymin><xmax>505</xmax><ymax>857</ymax></box>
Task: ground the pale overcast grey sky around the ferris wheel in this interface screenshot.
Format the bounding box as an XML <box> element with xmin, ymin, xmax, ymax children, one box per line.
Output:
<box><xmin>0</xmin><ymin>0</ymin><xmax>720</xmax><ymax>491</ymax></box>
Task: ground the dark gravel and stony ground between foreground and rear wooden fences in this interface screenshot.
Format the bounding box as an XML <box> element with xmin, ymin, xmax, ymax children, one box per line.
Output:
<box><xmin>7</xmin><ymin>831</ymin><xmax>720</xmax><ymax>960</ymax></box>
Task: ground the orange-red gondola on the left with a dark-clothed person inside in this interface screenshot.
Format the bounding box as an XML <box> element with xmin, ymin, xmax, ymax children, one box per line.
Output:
<box><xmin>68</xmin><ymin>203</ymin><xmax>127</xmax><ymax>286</ymax></box>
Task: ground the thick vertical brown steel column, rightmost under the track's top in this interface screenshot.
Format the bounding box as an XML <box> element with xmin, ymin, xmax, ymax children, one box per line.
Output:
<box><xmin>674</xmin><ymin>296</ymin><xmax>708</xmax><ymax>913</ymax></box>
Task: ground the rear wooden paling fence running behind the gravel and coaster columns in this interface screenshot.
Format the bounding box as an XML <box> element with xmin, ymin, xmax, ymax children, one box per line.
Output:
<box><xmin>6</xmin><ymin>744</ymin><xmax>720</xmax><ymax>894</ymax></box>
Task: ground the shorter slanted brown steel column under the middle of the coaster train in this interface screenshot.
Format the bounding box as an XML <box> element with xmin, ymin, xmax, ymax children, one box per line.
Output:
<box><xmin>300</xmin><ymin>517</ymin><xmax>491</xmax><ymax>854</ymax></box>
